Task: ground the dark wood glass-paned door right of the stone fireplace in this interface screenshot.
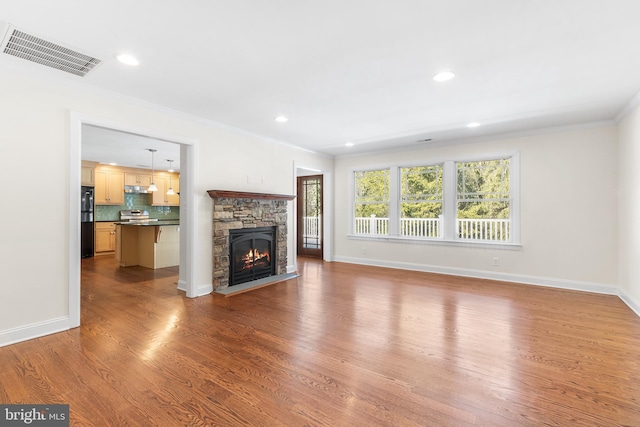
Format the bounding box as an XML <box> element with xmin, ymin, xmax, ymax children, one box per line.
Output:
<box><xmin>296</xmin><ymin>175</ymin><xmax>324</xmax><ymax>259</ymax></box>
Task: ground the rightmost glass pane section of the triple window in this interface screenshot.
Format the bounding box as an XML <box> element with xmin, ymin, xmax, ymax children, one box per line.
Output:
<box><xmin>456</xmin><ymin>159</ymin><xmax>511</xmax><ymax>241</ymax></box>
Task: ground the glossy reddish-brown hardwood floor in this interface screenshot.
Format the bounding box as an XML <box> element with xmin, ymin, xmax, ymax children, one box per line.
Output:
<box><xmin>0</xmin><ymin>257</ymin><xmax>640</xmax><ymax>426</ymax></box>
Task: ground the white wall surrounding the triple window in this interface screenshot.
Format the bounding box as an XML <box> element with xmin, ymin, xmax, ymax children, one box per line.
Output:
<box><xmin>335</xmin><ymin>127</ymin><xmax>617</xmax><ymax>293</ymax></box>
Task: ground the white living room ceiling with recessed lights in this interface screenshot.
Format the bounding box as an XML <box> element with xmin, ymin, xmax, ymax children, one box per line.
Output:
<box><xmin>0</xmin><ymin>0</ymin><xmax>640</xmax><ymax>159</ymax></box>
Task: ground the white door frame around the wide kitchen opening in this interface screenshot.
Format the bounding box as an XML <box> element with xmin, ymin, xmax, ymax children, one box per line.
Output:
<box><xmin>68</xmin><ymin>111</ymin><xmax>199</xmax><ymax>328</ymax></box>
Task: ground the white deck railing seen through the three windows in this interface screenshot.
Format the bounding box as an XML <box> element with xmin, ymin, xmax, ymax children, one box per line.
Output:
<box><xmin>354</xmin><ymin>216</ymin><xmax>511</xmax><ymax>242</ymax></box>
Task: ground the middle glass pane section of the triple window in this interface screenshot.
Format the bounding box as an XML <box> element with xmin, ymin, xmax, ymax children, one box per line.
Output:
<box><xmin>400</xmin><ymin>165</ymin><xmax>443</xmax><ymax>237</ymax></box>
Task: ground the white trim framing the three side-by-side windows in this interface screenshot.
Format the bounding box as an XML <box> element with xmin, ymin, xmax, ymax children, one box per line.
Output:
<box><xmin>347</xmin><ymin>152</ymin><xmax>521</xmax><ymax>248</ymax></box>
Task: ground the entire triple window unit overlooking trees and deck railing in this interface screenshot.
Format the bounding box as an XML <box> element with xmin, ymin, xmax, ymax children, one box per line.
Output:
<box><xmin>352</xmin><ymin>154</ymin><xmax>520</xmax><ymax>244</ymax></box>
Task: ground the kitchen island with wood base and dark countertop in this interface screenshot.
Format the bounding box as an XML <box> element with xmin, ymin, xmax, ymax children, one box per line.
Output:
<box><xmin>116</xmin><ymin>220</ymin><xmax>180</xmax><ymax>269</ymax></box>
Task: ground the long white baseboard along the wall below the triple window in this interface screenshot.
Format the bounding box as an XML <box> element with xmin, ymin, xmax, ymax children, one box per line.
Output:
<box><xmin>335</xmin><ymin>256</ymin><xmax>619</xmax><ymax>295</ymax></box>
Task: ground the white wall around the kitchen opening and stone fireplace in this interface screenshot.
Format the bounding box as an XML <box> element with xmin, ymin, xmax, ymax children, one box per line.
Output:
<box><xmin>0</xmin><ymin>70</ymin><xmax>333</xmax><ymax>345</ymax></box>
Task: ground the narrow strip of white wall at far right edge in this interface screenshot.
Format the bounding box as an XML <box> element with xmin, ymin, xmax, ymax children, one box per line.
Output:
<box><xmin>618</xmin><ymin>103</ymin><xmax>640</xmax><ymax>315</ymax></box>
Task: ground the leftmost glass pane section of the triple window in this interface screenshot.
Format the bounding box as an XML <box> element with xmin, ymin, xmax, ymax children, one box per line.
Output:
<box><xmin>354</xmin><ymin>169</ymin><xmax>389</xmax><ymax>234</ymax></box>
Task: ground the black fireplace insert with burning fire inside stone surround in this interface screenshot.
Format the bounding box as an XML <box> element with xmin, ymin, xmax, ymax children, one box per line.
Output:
<box><xmin>229</xmin><ymin>227</ymin><xmax>276</xmax><ymax>286</ymax></box>
